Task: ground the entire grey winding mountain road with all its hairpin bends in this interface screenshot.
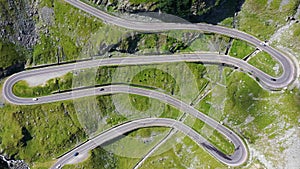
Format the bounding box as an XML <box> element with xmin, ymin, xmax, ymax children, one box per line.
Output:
<box><xmin>3</xmin><ymin>0</ymin><xmax>296</xmax><ymax>168</ymax></box>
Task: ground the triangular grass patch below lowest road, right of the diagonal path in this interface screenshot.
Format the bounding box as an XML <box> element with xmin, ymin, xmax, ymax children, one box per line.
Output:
<box><xmin>141</xmin><ymin>133</ymin><xmax>225</xmax><ymax>169</ymax></box>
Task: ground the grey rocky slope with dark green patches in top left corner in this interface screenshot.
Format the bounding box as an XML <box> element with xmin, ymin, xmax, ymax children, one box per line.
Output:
<box><xmin>0</xmin><ymin>0</ymin><xmax>37</xmax><ymax>78</ymax></box>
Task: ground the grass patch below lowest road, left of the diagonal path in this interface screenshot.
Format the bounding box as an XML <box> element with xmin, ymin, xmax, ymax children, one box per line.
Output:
<box><xmin>64</xmin><ymin>127</ymin><xmax>168</xmax><ymax>169</ymax></box>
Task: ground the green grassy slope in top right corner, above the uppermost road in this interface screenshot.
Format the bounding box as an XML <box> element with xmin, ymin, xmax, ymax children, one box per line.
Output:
<box><xmin>238</xmin><ymin>0</ymin><xmax>300</xmax><ymax>40</ymax></box>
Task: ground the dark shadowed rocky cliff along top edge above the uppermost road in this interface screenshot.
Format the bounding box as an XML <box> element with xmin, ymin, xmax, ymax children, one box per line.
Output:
<box><xmin>86</xmin><ymin>0</ymin><xmax>245</xmax><ymax>24</ymax></box>
